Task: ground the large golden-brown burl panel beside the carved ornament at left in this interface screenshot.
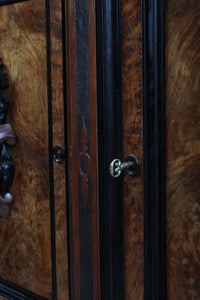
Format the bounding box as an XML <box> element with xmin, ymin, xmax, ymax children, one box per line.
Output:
<box><xmin>0</xmin><ymin>0</ymin><xmax>52</xmax><ymax>299</ymax></box>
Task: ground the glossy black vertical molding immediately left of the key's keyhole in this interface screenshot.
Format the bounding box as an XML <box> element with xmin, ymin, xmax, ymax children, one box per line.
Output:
<box><xmin>96</xmin><ymin>0</ymin><xmax>125</xmax><ymax>300</ymax></box>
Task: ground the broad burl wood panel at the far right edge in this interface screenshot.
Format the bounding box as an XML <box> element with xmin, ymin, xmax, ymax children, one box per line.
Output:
<box><xmin>166</xmin><ymin>0</ymin><xmax>200</xmax><ymax>300</ymax></box>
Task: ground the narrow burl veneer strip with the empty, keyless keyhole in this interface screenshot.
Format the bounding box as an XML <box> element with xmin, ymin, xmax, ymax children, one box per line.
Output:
<box><xmin>50</xmin><ymin>0</ymin><xmax>69</xmax><ymax>300</ymax></box>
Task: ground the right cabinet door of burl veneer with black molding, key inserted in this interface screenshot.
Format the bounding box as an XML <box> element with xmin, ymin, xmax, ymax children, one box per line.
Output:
<box><xmin>121</xmin><ymin>0</ymin><xmax>200</xmax><ymax>300</ymax></box>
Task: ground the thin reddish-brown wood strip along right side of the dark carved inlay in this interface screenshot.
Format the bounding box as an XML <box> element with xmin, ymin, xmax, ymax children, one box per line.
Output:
<box><xmin>88</xmin><ymin>0</ymin><xmax>100</xmax><ymax>299</ymax></box>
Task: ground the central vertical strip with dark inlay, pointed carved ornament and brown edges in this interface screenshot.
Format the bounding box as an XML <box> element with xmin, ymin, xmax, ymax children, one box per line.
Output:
<box><xmin>66</xmin><ymin>0</ymin><xmax>99</xmax><ymax>300</ymax></box>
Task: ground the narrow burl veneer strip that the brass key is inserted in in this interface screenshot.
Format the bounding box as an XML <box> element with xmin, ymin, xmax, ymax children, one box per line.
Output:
<box><xmin>121</xmin><ymin>0</ymin><xmax>143</xmax><ymax>300</ymax></box>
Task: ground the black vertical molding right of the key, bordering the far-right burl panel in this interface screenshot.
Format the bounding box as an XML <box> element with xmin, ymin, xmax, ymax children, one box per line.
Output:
<box><xmin>142</xmin><ymin>0</ymin><xmax>166</xmax><ymax>300</ymax></box>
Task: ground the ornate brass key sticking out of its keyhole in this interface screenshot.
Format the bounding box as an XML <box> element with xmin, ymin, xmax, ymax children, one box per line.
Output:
<box><xmin>110</xmin><ymin>154</ymin><xmax>139</xmax><ymax>178</ymax></box>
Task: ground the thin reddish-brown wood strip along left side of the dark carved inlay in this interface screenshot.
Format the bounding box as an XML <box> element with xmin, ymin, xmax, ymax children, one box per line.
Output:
<box><xmin>67</xmin><ymin>0</ymin><xmax>80</xmax><ymax>300</ymax></box>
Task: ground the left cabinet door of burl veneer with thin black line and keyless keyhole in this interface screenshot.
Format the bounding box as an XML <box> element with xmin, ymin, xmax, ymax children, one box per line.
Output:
<box><xmin>0</xmin><ymin>0</ymin><xmax>68</xmax><ymax>299</ymax></box>
